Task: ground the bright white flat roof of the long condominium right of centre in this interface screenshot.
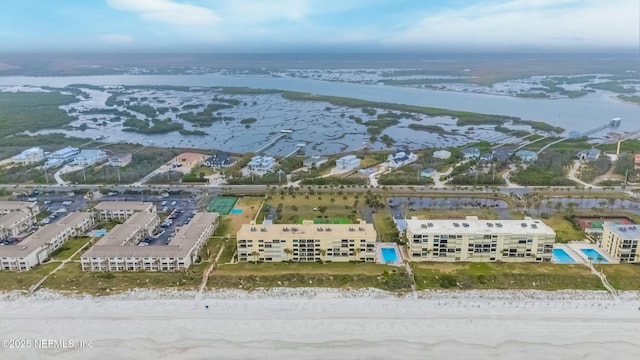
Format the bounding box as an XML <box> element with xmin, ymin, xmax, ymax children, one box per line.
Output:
<box><xmin>407</xmin><ymin>219</ymin><xmax>555</xmax><ymax>235</ymax></box>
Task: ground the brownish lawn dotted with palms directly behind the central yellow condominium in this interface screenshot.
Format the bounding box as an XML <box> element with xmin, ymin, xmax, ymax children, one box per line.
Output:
<box><xmin>265</xmin><ymin>190</ymin><xmax>365</xmax><ymax>224</ymax></box>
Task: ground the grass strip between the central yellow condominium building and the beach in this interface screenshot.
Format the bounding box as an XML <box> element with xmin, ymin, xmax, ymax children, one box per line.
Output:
<box><xmin>207</xmin><ymin>262</ymin><xmax>411</xmax><ymax>291</ymax></box>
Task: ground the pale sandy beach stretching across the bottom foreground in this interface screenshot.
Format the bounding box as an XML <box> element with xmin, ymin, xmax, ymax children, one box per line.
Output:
<box><xmin>0</xmin><ymin>289</ymin><xmax>640</xmax><ymax>360</ymax></box>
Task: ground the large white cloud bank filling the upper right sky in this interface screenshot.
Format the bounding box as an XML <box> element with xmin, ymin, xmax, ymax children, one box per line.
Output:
<box><xmin>383</xmin><ymin>0</ymin><xmax>638</xmax><ymax>48</ymax></box>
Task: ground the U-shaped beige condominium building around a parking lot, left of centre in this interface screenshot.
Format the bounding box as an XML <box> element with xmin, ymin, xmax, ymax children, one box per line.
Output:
<box><xmin>80</xmin><ymin>213</ymin><xmax>218</xmax><ymax>271</ymax></box>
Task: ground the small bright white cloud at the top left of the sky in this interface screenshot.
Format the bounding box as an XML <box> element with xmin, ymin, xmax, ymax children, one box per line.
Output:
<box><xmin>107</xmin><ymin>0</ymin><xmax>222</xmax><ymax>26</ymax></box>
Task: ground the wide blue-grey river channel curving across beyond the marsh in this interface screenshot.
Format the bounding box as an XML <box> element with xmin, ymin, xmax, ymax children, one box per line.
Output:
<box><xmin>0</xmin><ymin>74</ymin><xmax>640</xmax><ymax>131</ymax></box>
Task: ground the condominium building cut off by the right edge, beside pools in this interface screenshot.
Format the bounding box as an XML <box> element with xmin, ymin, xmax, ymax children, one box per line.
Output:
<box><xmin>604</xmin><ymin>222</ymin><xmax>640</xmax><ymax>263</ymax></box>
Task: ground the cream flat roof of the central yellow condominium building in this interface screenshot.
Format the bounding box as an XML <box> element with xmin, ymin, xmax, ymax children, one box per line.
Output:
<box><xmin>237</xmin><ymin>220</ymin><xmax>377</xmax><ymax>240</ymax></box>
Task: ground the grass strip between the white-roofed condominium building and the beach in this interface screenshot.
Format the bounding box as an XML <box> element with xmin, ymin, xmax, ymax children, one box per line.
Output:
<box><xmin>411</xmin><ymin>263</ymin><xmax>604</xmax><ymax>290</ymax></box>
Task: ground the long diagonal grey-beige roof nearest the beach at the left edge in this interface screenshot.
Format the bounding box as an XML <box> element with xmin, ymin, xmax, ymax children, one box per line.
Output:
<box><xmin>0</xmin><ymin>212</ymin><xmax>93</xmax><ymax>258</ymax></box>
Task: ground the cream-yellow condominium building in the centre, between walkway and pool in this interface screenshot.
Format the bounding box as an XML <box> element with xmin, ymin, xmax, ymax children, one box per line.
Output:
<box><xmin>237</xmin><ymin>220</ymin><xmax>377</xmax><ymax>262</ymax></box>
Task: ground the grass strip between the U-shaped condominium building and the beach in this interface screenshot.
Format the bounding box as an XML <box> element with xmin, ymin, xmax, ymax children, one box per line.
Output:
<box><xmin>42</xmin><ymin>263</ymin><xmax>209</xmax><ymax>295</ymax></box>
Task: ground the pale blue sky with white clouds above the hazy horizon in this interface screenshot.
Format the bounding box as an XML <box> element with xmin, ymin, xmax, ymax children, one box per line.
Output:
<box><xmin>0</xmin><ymin>0</ymin><xmax>640</xmax><ymax>53</ymax></box>
